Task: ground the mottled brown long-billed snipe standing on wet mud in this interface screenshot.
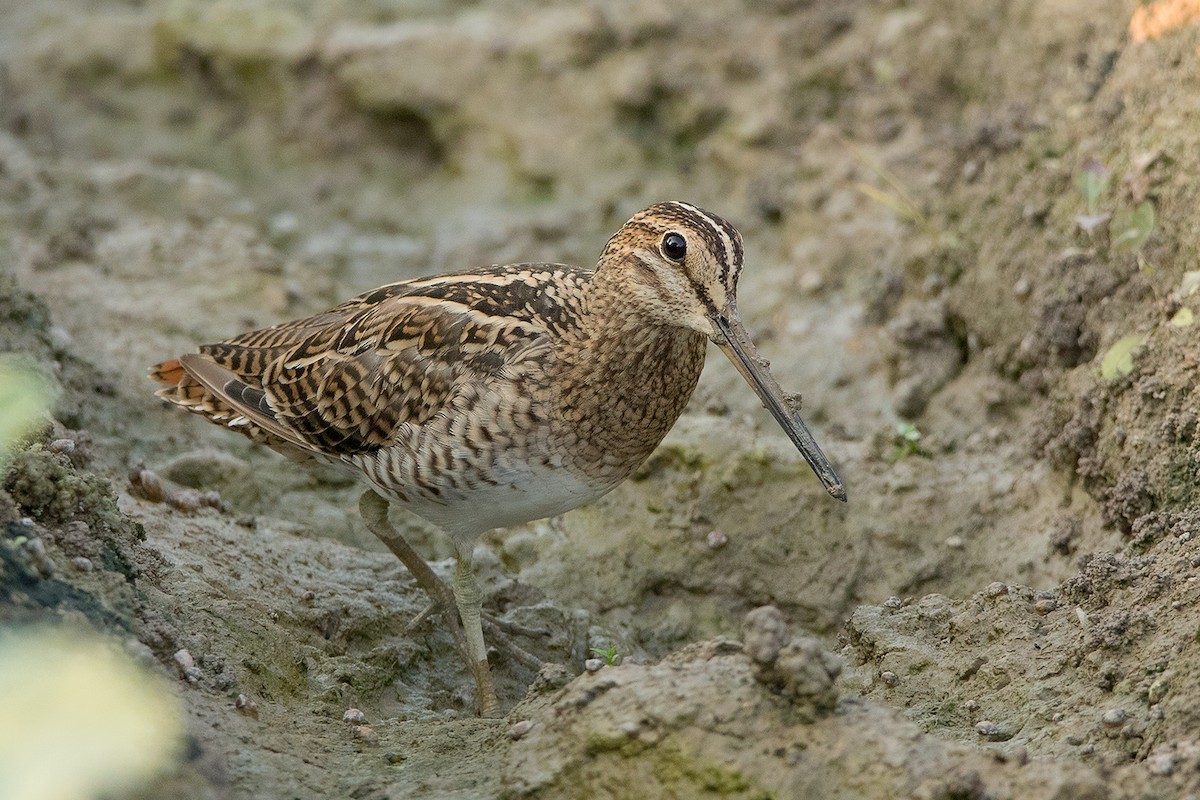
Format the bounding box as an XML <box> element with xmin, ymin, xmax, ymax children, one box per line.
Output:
<box><xmin>151</xmin><ymin>203</ymin><xmax>845</xmax><ymax>711</ymax></box>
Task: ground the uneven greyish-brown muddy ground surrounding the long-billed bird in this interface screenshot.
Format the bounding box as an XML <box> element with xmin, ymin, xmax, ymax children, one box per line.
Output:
<box><xmin>0</xmin><ymin>0</ymin><xmax>1200</xmax><ymax>799</ymax></box>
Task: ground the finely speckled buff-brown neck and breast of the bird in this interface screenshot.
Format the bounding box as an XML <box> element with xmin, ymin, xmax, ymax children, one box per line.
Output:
<box><xmin>554</xmin><ymin>270</ymin><xmax>707</xmax><ymax>485</ymax></box>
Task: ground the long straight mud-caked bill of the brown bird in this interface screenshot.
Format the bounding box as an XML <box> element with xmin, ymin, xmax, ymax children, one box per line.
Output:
<box><xmin>714</xmin><ymin>303</ymin><xmax>846</xmax><ymax>503</ymax></box>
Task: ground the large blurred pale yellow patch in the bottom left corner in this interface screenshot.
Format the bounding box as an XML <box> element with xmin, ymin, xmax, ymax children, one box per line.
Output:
<box><xmin>0</xmin><ymin>628</ymin><xmax>182</xmax><ymax>800</ymax></box>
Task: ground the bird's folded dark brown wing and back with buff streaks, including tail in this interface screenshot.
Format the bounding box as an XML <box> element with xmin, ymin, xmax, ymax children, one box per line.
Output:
<box><xmin>151</xmin><ymin>265</ymin><xmax>589</xmax><ymax>458</ymax></box>
